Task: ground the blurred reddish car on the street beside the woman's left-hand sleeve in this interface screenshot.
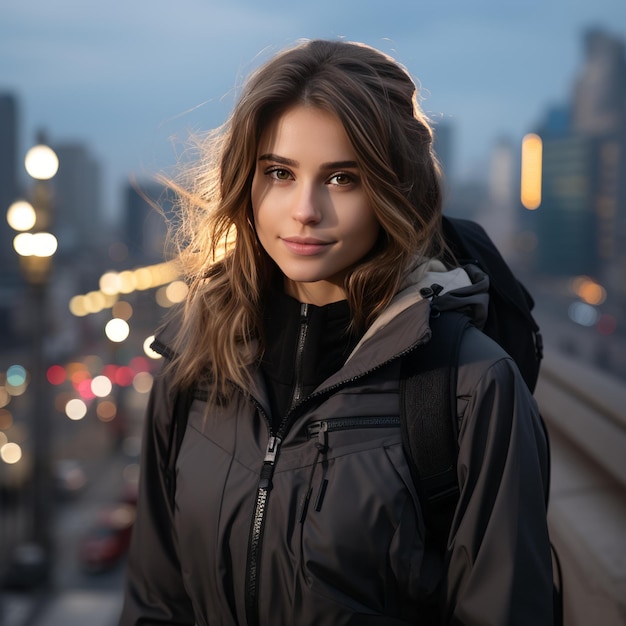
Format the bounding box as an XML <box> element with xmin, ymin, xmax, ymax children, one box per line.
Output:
<box><xmin>78</xmin><ymin>503</ymin><xmax>135</xmax><ymax>573</ymax></box>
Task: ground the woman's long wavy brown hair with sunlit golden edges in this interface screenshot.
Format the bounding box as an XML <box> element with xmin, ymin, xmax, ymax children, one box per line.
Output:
<box><xmin>162</xmin><ymin>40</ymin><xmax>444</xmax><ymax>398</ymax></box>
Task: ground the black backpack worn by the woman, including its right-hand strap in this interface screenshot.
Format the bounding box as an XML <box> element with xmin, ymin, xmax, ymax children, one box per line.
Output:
<box><xmin>400</xmin><ymin>217</ymin><xmax>563</xmax><ymax>626</ymax></box>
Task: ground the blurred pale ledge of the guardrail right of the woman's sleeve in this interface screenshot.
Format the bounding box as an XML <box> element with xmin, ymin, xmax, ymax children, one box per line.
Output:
<box><xmin>535</xmin><ymin>349</ymin><xmax>626</xmax><ymax>626</ymax></box>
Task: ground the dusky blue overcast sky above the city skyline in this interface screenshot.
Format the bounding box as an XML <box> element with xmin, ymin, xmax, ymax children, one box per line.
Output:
<box><xmin>0</xmin><ymin>0</ymin><xmax>626</xmax><ymax>217</ymax></box>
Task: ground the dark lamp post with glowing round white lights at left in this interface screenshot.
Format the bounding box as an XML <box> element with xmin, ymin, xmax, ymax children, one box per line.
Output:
<box><xmin>7</xmin><ymin>133</ymin><xmax>59</xmax><ymax>585</ymax></box>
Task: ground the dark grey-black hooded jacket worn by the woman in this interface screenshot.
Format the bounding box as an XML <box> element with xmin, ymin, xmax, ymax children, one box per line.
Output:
<box><xmin>120</xmin><ymin>260</ymin><xmax>552</xmax><ymax>626</ymax></box>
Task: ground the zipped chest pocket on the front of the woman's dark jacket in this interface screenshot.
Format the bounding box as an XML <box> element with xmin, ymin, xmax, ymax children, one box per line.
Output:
<box><xmin>299</xmin><ymin>416</ymin><xmax>423</xmax><ymax>605</ymax></box>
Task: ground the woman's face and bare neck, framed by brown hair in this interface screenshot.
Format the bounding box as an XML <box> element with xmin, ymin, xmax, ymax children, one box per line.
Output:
<box><xmin>252</xmin><ymin>105</ymin><xmax>380</xmax><ymax>306</ymax></box>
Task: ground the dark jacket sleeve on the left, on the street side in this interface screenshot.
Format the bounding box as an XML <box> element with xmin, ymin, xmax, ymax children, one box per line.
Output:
<box><xmin>119</xmin><ymin>364</ymin><xmax>195</xmax><ymax>626</ymax></box>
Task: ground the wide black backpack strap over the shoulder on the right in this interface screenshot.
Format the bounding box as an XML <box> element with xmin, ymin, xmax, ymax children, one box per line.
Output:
<box><xmin>400</xmin><ymin>309</ymin><xmax>471</xmax><ymax>548</ymax></box>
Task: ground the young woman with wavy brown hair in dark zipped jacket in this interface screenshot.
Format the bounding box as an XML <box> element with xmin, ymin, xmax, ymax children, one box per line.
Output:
<box><xmin>120</xmin><ymin>41</ymin><xmax>552</xmax><ymax>626</ymax></box>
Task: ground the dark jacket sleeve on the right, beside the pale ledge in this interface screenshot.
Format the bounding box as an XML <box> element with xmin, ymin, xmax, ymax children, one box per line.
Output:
<box><xmin>444</xmin><ymin>336</ymin><xmax>553</xmax><ymax>626</ymax></box>
